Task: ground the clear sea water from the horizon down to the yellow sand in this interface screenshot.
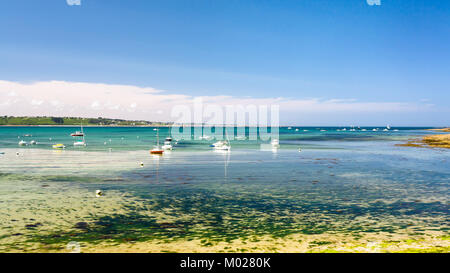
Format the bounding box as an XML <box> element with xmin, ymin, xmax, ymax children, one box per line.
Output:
<box><xmin>0</xmin><ymin>127</ymin><xmax>450</xmax><ymax>251</ymax></box>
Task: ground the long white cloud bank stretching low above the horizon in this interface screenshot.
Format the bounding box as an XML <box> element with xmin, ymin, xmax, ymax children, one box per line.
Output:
<box><xmin>0</xmin><ymin>78</ymin><xmax>433</xmax><ymax>122</ymax></box>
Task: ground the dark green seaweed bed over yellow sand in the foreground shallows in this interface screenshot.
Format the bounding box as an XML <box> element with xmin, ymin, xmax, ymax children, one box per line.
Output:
<box><xmin>0</xmin><ymin>174</ymin><xmax>449</xmax><ymax>252</ymax></box>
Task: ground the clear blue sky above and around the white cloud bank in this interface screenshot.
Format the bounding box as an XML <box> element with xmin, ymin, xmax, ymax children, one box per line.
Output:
<box><xmin>0</xmin><ymin>0</ymin><xmax>450</xmax><ymax>126</ymax></box>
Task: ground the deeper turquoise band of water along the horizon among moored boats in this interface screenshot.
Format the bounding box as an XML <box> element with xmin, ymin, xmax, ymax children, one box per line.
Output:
<box><xmin>0</xmin><ymin>127</ymin><xmax>436</xmax><ymax>151</ymax></box>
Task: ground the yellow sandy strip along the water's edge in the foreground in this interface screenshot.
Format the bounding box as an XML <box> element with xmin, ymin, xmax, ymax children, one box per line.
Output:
<box><xmin>8</xmin><ymin>232</ymin><xmax>450</xmax><ymax>253</ymax></box>
